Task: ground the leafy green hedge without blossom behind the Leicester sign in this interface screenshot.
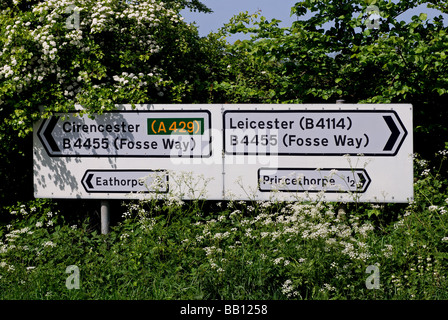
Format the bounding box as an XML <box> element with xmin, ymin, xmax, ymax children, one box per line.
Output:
<box><xmin>214</xmin><ymin>0</ymin><xmax>448</xmax><ymax>157</ymax></box>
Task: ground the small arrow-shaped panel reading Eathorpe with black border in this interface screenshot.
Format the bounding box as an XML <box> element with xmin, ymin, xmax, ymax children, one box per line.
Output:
<box><xmin>81</xmin><ymin>169</ymin><xmax>169</xmax><ymax>193</ymax></box>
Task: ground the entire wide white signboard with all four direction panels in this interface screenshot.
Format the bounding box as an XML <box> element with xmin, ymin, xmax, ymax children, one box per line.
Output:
<box><xmin>33</xmin><ymin>104</ymin><xmax>413</xmax><ymax>202</ymax></box>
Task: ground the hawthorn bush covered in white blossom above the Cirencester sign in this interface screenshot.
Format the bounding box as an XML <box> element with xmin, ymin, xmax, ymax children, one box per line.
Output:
<box><xmin>0</xmin><ymin>0</ymin><xmax>221</xmax><ymax>209</ymax></box>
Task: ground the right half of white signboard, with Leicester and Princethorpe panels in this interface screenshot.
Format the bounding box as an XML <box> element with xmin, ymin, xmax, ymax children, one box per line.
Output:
<box><xmin>222</xmin><ymin>104</ymin><xmax>413</xmax><ymax>202</ymax></box>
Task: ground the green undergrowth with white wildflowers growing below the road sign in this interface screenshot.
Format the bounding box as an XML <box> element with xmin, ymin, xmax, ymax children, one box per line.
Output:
<box><xmin>0</xmin><ymin>154</ymin><xmax>448</xmax><ymax>300</ymax></box>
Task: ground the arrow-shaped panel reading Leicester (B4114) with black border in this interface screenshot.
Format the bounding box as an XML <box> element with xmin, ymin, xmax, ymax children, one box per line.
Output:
<box><xmin>223</xmin><ymin>110</ymin><xmax>408</xmax><ymax>156</ymax></box>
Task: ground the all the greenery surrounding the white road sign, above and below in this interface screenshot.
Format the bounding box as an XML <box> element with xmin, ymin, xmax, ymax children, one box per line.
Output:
<box><xmin>0</xmin><ymin>0</ymin><xmax>448</xmax><ymax>299</ymax></box>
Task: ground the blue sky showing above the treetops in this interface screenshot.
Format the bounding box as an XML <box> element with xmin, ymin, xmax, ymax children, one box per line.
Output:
<box><xmin>182</xmin><ymin>0</ymin><xmax>446</xmax><ymax>42</ymax></box>
